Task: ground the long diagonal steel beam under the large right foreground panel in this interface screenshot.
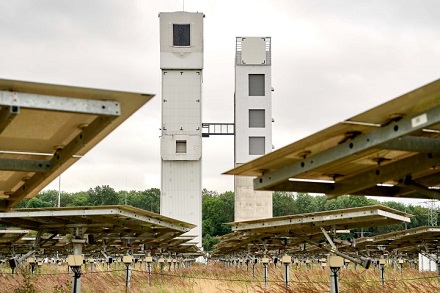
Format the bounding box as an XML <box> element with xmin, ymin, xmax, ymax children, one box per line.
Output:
<box><xmin>254</xmin><ymin>106</ymin><xmax>440</xmax><ymax>190</ymax></box>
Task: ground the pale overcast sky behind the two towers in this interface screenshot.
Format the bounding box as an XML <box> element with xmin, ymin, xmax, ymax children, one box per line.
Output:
<box><xmin>0</xmin><ymin>0</ymin><xmax>440</xmax><ymax>205</ymax></box>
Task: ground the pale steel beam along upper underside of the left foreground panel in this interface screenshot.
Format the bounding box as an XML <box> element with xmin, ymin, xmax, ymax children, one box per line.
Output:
<box><xmin>0</xmin><ymin>91</ymin><xmax>121</xmax><ymax>116</ymax></box>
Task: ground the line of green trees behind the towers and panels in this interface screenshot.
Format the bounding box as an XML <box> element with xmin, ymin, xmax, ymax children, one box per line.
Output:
<box><xmin>9</xmin><ymin>185</ymin><xmax>435</xmax><ymax>251</ymax></box>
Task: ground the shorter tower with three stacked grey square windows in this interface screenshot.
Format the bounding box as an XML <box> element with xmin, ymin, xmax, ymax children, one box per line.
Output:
<box><xmin>234</xmin><ymin>37</ymin><xmax>272</xmax><ymax>221</ymax></box>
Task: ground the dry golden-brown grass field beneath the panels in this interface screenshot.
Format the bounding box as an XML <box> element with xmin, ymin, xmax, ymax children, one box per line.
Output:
<box><xmin>0</xmin><ymin>263</ymin><xmax>440</xmax><ymax>293</ymax></box>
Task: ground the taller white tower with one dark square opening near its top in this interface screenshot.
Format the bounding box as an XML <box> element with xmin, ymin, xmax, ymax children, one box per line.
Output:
<box><xmin>159</xmin><ymin>11</ymin><xmax>204</xmax><ymax>247</ymax></box>
